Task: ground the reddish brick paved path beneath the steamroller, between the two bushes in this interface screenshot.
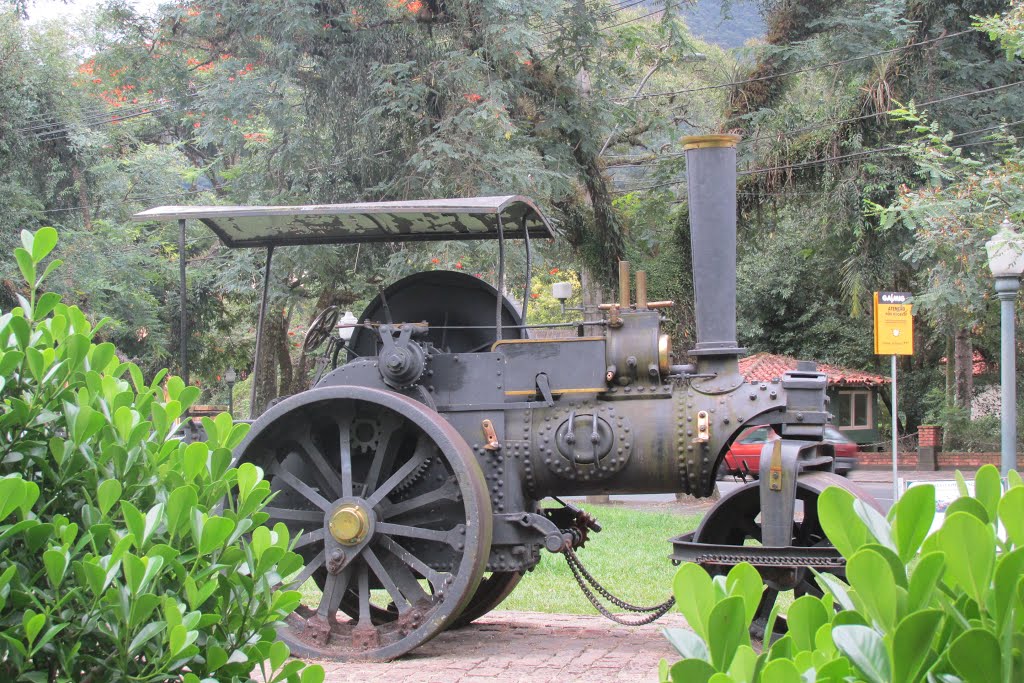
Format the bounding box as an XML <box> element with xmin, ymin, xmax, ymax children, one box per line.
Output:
<box><xmin>324</xmin><ymin>611</ymin><xmax>686</xmax><ymax>683</ymax></box>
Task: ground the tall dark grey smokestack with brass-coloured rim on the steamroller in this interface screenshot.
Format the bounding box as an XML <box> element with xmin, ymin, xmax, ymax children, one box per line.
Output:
<box><xmin>683</xmin><ymin>135</ymin><xmax>742</xmax><ymax>356</ymax></box>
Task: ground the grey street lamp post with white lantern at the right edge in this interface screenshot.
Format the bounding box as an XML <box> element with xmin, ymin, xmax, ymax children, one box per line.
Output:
<box><xmin>985</xmin><ymin>218</ymin><xmax>1024</xmax><ymax>476</ymax></box>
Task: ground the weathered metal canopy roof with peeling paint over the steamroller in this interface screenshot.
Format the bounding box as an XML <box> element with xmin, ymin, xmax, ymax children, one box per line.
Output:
<box><xmin>132</xmin><ymin>195</ymin><xmax>554</xmax><ymax>248</ymax></box>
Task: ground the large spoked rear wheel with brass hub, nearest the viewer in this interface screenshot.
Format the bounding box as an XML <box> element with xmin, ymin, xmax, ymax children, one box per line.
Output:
<box><xmin>236</xmin><ymin>386</ymin><xmax>493</xmax><ymax>660</ymax></box>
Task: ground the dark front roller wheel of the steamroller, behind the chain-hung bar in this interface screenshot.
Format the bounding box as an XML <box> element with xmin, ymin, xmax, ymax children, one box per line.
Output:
<box><xmin>693</xmin><ymin>472</ymin><xmax>882</xmax><ymax>638</ymax></box>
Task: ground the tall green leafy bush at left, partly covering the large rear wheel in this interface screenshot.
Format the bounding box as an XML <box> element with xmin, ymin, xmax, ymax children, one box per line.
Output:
<box><xmin>0</xmin><ymin>228</ymin><xmax>324</xmax><ymax>683</ymax></box>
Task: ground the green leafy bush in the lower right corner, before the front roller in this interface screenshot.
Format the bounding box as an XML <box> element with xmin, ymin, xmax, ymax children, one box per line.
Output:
<box><xmin>659</xmin><ymin>465</ymin><xmax>1024</xmax><ymax>683</ymax></box>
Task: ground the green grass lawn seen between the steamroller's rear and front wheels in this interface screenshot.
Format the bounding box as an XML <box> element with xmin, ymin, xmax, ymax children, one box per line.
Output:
<box><xmin>499</xmin><ymin>505</ymin><xmax>700</xmax><ymax>614</ymax></box>
